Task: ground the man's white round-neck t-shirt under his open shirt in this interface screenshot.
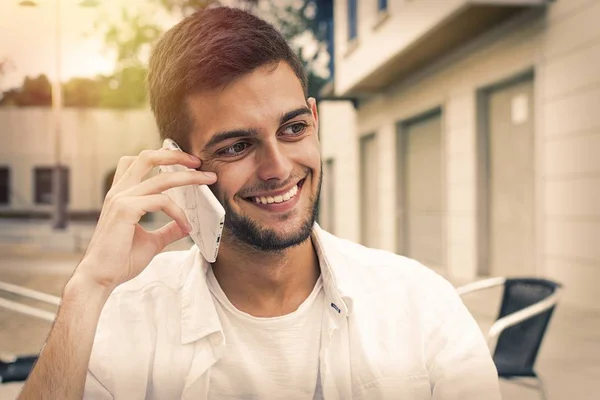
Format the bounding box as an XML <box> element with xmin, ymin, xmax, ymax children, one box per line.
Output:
<box><xmin>207</xmin><ymin>268</ymin><xmax>325</xmax><ymax>400</ymax></box>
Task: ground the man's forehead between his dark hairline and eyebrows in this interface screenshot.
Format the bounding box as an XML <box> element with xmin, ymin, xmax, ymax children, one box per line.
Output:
<box><xmin>188</xmin><ymin>62</ymin><xmax>306</xmax><ymax>147</ymax></box>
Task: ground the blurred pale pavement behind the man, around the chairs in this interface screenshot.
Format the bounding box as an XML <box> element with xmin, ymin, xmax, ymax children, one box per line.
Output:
<box><xmin>0</xmin><ymin>233</ymin><xmax>600</xmax><ymax>400</ymax></box>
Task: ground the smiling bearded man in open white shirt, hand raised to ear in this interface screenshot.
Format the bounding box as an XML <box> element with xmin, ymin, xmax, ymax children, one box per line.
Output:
<box><xmin>21</xmin><ymin>8</ymin><xmax>499</xmax><ymax>400</ymax></box>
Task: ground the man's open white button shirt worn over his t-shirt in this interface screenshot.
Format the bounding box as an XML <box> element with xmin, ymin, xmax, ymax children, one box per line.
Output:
<box><xmin>84</xmin><ymin>225</ymin><xmax>500</xmax><ymax>400</ymax></box>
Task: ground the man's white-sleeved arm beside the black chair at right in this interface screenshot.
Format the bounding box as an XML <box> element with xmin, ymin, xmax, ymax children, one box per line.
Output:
<box><xmin>427</xmin><ymin>281</ymin><xmax>501</xmax><ymax>400</ymax></box>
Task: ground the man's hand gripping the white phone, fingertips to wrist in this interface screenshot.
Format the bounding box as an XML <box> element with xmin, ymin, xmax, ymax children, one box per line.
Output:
<box><xmin>76</xmin><ymin>149</ymin><xmax>216</xmax><ymax>290</ymax></box>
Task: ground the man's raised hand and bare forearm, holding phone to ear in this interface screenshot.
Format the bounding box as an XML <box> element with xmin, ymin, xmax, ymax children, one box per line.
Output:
<box><xmin>19</xmin><ymin>150</ymin><xmax>216</xmax><ymax>400</ymax></box>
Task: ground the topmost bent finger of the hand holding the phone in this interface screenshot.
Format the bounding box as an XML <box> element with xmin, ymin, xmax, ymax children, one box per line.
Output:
<box><xmin>123</xmin><ymin>149</ymin><xmax>201</xmax><ymax>186</ymax></box>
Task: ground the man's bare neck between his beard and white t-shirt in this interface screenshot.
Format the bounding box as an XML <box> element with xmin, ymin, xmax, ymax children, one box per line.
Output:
<box><xmin>212</xmin><ymin>238</ymin><xmax>321</xmax><ymax>317</ymax></box>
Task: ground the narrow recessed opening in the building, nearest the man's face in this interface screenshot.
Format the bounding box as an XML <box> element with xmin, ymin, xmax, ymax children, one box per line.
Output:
<box><xmin>360</xmin><ymin>135</ymin><xmax>379</xmax><ymax>247</ymax></box>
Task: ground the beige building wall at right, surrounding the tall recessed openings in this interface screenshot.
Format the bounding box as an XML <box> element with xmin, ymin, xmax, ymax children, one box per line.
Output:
<box><xmin>321</xmin><ymin>0</ymin><xmax>600</xmax><ymax>308</ymax></box>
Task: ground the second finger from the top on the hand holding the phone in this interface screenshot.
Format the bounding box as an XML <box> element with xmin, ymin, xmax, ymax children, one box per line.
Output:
<box><xmin>123</xmin><ymin>171</ymin><xmax>217</xmax><ymax>196</ymax></box>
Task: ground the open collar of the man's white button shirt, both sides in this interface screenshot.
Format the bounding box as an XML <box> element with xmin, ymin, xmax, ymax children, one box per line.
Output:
<box><xmin>180</xmin><ymin>223</ymin><xmax>358</xmax><ymax>344</ymax></box>
